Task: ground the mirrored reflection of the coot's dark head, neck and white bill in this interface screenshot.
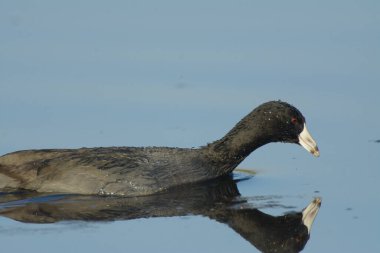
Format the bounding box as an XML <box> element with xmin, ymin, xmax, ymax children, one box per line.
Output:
<box><xmin>213</xmin><ymin>198</ymin><xmax>321</xmax><ymax>252</ymax></box>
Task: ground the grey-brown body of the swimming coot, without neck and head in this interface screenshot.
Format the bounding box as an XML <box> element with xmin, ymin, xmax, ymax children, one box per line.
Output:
<box><xmin>0</xmin><ymin>147</ymin><xmax>210</xmax><ymax>196</ymax></box>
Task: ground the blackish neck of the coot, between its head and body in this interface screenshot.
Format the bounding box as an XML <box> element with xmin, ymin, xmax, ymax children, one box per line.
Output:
<box><xmin>205</xmin><ymin>114</ymin><xmax>271</xmax><ymax>174</ymax></box>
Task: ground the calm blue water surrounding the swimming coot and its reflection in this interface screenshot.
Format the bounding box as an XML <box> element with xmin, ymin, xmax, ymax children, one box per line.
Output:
<box><xmin>0</xmin><ymin>1</ymin><xmax>380</xmax><ymax>253</ymax></box>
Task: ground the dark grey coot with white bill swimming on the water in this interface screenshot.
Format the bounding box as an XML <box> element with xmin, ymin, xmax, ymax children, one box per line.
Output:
<box><xmin>0</xmin><ymin>101</ymin><xmax>319</xmax><ymax>196</ymax></box>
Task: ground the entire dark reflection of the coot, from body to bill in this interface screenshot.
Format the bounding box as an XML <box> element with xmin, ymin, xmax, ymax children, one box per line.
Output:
<box><xmin>0</xmin><ymin>176</ymin><xmax>321</xmax><ymax>252</ymax></box>
